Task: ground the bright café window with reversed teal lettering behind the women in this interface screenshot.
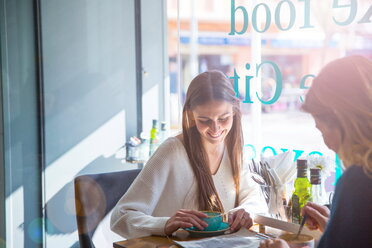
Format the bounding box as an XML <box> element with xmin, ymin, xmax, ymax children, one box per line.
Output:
<box><xmin>168</xmin><ymin>0</ymin><xmax>372</xmax><ymax>196</ymax></box>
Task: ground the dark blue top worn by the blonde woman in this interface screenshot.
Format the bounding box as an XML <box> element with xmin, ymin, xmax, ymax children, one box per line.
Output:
<box><xmin>318</xmin><ymin>166</ymin><xmax>372</xmax><ymax>248</ymax></box>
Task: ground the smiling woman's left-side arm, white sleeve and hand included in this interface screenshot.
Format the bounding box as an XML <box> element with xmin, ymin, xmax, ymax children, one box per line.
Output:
<box><xmin>111</xmin><ymin>138</ymin><xmax>206</xmax><ymax>238</ymax></box>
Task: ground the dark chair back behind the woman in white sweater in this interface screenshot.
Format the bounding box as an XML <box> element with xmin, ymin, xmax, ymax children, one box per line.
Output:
<box><xmin>74</xmin><ymin>169</ymin><xmax>141</xmax><ymax>248</ymax></box>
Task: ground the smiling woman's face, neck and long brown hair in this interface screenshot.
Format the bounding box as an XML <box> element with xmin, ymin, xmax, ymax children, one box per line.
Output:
<box><xmin>182</xmin><ymin>71</ymin><xmax>243</xmax><ymax>211</ymax></box>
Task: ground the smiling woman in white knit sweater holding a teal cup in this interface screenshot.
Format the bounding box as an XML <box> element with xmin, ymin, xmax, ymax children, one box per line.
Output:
<box><xmin>111</xmin><ymin>71</ymin><xmax>266</xmax><ymax>238</ymax></box>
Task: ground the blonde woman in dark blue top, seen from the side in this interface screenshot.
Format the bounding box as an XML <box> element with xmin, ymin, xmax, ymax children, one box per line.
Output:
<box><xmin>260</xmin><ymin>56</ymin><xmax>372</xmax><ymax>248</ymax></box>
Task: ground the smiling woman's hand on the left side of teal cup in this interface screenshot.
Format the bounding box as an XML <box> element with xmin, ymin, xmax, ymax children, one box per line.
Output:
<box><xmin>164</xmin><ymin>209</ymin><xmax>208</xmax><ymax>235</ymax></box>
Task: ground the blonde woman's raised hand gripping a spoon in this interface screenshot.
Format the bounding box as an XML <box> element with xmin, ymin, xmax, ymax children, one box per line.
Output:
<box><xmin>301</xmin><ymin>202</ymin><xmax>329</xmax><ymax>232</ymax></box>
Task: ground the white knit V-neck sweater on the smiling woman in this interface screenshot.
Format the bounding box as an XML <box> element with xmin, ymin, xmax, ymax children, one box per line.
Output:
<box><xmin>111</xmin><ymin>137</ymin><xmax>267</xmax><ymax>238</ymax></box>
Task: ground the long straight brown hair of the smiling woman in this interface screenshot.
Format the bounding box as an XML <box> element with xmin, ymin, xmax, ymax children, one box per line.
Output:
<box><xmin>182</xmin><ymin>71</ymin><xmax>243</xmax><ymax>212</ymax></box>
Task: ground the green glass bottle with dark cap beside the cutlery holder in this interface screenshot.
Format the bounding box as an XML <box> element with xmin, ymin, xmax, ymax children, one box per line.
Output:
<box><xmin>292</xmin><ymin>159</ymin><xmax>311</xmax><ymax>224</ymax></box>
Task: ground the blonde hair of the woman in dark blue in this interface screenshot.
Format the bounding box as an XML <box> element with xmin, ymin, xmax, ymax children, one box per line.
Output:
<box><xmin>302</xmin><ymin>56</ymin><xmax>372</xmax><ymax>177</ymax></box>
